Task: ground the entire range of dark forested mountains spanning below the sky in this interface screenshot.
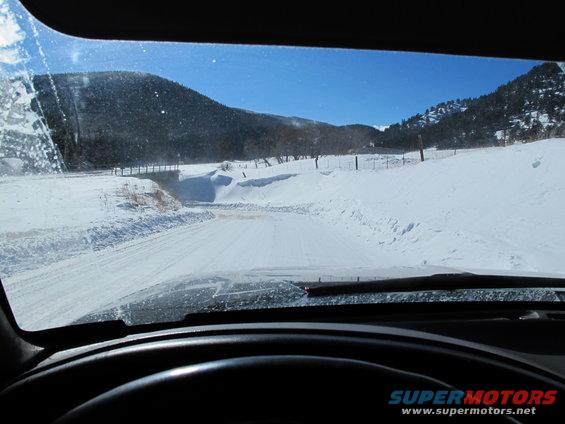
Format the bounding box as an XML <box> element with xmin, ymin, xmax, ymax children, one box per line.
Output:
<box><xmin>29</xmin><ymin>62</ymin><xmax>565</xmax><ymax>168</ymax></box>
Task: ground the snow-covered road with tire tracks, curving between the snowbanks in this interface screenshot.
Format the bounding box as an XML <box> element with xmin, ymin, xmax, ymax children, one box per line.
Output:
<box><xmin>7</xmin><ymin>209</ymin><xmax>387</xmax><ymax>330</ymax></box>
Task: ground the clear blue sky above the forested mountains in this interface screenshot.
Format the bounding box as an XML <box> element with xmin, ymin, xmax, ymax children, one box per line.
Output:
<box><xmin>9</xmin><ymin>0</ymin><xmax>540</xmax><ymax>125</ymax></box>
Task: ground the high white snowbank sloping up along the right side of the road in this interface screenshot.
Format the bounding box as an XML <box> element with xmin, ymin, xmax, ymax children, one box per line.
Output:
<box><xmin>207</xmin><ymin>139</ymin><xmax>565</xmax><ymax>274</ymax></box>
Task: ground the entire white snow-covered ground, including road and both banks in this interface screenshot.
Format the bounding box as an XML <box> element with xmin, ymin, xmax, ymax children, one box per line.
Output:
<box><xmin>0</xmin><ymin>139</ymin><xmax>565</xmax><ymax>329</ymax></box>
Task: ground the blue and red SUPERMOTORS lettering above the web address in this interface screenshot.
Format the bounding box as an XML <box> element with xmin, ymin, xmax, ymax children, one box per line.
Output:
<box><xmin>388</xmin><ymin>390</ymin><xmax>557</xmax><ymax>406</ymax></box>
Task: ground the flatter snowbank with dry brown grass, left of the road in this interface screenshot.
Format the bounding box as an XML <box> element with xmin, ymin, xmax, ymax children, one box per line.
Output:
<box><xmin>0</xmin><ymin>174</ymin><xmax>213</xmax><ymax>277</ymax></box>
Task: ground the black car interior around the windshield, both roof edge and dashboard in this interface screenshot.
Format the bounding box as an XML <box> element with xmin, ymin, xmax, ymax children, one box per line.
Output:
<box><xmin>0</xmin><ymin>0</ymin><xmax>565</xmax><ymax>423</ymax></box>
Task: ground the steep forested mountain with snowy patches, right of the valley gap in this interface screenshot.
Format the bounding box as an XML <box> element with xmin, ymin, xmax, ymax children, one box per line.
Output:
<box><xmin>380</xmin><ymin>62</ymin><xmax>565</xmax><ymax>149</ymax></box>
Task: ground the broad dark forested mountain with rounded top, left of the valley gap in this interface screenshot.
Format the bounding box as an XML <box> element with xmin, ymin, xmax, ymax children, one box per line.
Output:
<box><xmin>34</xmin><ymin>72</ymin><xmax>380</xmax><ymax>168</ymax></box>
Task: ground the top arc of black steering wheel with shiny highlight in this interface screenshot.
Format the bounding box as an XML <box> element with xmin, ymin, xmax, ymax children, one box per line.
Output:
<box><xmin>56</xmin><ymin>356</ymin><xmax>468</xmax><ymax>424</ymax></box>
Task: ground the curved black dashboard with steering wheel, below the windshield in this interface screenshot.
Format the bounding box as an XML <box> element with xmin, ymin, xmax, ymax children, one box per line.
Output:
<box><xmin>0</xmin><ymin>305</ymin><xmax>565</xmax><ymax>422</ymax></box>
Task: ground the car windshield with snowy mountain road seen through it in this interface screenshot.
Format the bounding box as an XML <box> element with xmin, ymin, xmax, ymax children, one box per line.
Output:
<box><xmin>0</xmin><ymin>0</ymin><xmax>565</xmax><ymax>330</ymax></box>
